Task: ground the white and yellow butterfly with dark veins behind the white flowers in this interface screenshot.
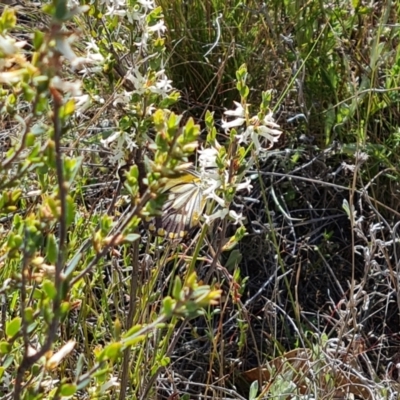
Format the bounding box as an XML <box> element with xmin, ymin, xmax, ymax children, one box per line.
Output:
<box><xmin>149</xmin><ymin>170</ymin><xmax>207</xmax><ymax>239</ymax></box>
